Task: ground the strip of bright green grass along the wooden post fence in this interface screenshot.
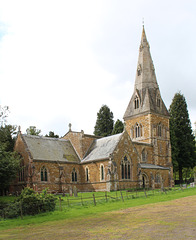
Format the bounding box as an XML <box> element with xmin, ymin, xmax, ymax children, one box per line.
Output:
<box><xmin>0</xmin><ymin>188</ymin><xmax>196</xmax><ymax>230</ymax></box>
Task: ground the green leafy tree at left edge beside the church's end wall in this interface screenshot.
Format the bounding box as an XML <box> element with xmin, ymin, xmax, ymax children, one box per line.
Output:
<box><xmin>0</xmin><ymin>146</ymin><xmax>20</xmax><ymax>191</ymax></box>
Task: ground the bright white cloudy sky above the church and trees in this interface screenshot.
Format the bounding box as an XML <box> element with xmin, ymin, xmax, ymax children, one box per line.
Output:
<box><xmin>0</xmin><ymin>0</ymin><xmax>196</xmax><ymax>136</ymax></box>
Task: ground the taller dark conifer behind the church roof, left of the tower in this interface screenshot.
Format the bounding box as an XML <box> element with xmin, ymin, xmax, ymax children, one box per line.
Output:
<box><xmin>94</xmin><ymin>105</ymin><xmax>114</xmax><ymax>137</ymax></box>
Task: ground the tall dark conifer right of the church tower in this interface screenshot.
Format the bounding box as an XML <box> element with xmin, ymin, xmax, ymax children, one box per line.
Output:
<box><xmin>169</xmin><ymin>93</ymin><xmax>196</xmax><ymax>183</ymax></box>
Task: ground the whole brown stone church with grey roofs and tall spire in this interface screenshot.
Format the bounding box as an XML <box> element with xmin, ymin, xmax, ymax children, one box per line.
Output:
<box><xmin>11</xmin><ymin>27</ymin><xmax>173</xmax><ymax>192</ymax></box>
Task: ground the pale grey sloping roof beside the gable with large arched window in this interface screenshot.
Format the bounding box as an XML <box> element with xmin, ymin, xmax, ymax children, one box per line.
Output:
<box><xmin>82</xmin><ymin>133</ymin><xmax>123</xmax><ymax>162</ymax></box>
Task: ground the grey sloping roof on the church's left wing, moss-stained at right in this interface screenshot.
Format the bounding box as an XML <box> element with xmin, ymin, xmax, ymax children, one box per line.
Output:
<box><xmin>22</xmin><ymin>134</ymin><xmax>80</xmax><ymax>162</ymax></box>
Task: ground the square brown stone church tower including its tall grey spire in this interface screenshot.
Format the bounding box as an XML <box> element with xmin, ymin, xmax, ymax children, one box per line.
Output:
<box><xmin>124</xmin><ymin>26</ymin><xmax>171</xmax><ymax>166</ymax></box>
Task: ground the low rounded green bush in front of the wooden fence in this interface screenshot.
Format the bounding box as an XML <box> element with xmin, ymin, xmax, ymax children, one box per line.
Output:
<box><xmin>1</xmin><ymin>188</ymin><xmax>56</xmax><ymax>218</ymax></box>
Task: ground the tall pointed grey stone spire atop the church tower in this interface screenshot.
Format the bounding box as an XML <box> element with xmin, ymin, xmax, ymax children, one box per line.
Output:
<box><xmin>124</xmin><ymin>26</ymin><xmax>169</xmax><ymax>120</ymax></box>
